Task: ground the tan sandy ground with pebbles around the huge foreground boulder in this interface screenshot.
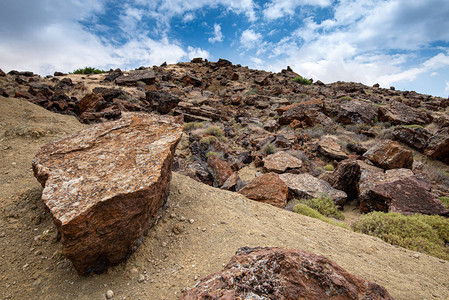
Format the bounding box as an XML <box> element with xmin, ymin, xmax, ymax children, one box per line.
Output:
<box><xmin>0</xmin><ymin>97</ymin><xmax>449</xmax><ymax>300</ymax></box>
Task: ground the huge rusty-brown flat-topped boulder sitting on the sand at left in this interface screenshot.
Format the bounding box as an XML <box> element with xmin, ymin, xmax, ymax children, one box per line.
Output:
<box><xmin>33</xmin><ymin>113</ymin><xmax>182</xmax><ymax>274</ymax></box>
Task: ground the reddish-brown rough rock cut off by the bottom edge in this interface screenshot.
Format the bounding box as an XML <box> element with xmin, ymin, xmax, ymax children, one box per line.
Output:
<box><xmin>180</xmin><ymin>247</ymin><xmax>392</xmax><ymax>300</ymax></box>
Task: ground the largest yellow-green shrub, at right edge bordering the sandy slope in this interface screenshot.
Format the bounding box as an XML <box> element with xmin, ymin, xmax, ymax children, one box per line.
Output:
<box><xmin>352</xmin><ymin>212</ymin><xmax>449</xmax><ymax>260</ymax></box>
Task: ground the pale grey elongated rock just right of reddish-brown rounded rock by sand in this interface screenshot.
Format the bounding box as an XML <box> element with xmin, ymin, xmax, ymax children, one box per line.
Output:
<box><xmin>279</xmin><ymin>173</ymin><xmax>347</xmax><ymax>205</ymax></box>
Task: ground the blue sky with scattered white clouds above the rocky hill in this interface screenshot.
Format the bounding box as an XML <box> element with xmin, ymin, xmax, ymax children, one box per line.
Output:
<box><xmin>0</xmin><ymin>0</ymin><xmax>449</xmax><ymax>97</ymax></box>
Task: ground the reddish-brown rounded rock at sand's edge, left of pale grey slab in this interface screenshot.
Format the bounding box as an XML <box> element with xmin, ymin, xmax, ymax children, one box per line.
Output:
<box><xmin>239</xmin><ymin>173</ymin><xmax>288</xmax><ymax>208</ymax></box>
